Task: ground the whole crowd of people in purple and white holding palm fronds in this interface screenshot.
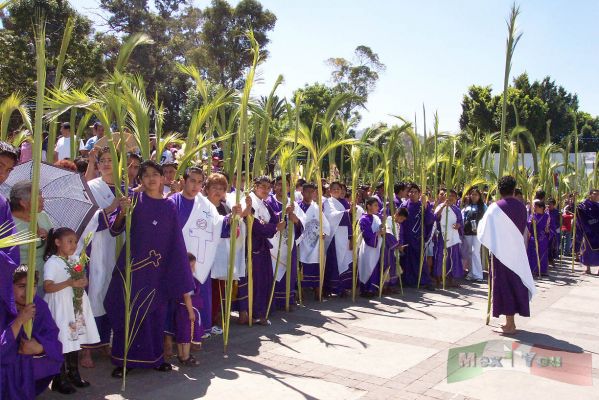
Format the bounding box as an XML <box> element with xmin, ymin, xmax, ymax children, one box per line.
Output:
<box><xmin>0</xmin><ymin>123</ymin><xmax>599</xmax><ymax>399</ymax></box>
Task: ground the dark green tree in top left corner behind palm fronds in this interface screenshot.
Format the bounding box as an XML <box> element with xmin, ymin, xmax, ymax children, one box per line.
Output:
<box><xmin>0</xmin><ymin>0</ymin><xmax>105</xmax><ymax>103</ymax></box>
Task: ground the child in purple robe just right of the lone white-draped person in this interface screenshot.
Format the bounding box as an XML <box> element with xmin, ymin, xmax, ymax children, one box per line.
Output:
<box><xmin>526</xmin><ymin>200</ymin><xmax>550</xmax><ymax>278</ymax></box>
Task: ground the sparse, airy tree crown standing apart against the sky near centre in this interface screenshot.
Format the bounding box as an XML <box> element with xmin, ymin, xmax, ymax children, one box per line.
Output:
<box><xmin>327</xmin><ymin>45</ymin><xmax>386</xmax><ymax>118</ymax></box>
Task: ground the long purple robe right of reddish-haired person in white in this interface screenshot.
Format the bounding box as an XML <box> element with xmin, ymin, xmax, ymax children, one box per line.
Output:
<box><xmin>237</xmin><ymin>197</ymin><xmax>279</xmax><ymax>319</ymax></box>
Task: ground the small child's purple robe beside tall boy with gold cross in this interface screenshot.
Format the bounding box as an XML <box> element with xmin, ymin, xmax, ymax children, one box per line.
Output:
<box><xmin>175</xmin><ymin>278</ymin><xmax>202</xmax><ymax>344</ymax></box>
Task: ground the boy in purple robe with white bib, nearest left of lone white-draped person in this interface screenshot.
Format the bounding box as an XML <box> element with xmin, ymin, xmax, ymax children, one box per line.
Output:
<box><xmin>434</xmin><ymin>189</ymin><xmax>464</xmax><ymax>287</ymax></box>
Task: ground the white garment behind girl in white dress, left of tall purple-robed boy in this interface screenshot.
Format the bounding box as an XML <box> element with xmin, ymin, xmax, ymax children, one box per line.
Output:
<box><xmin>75</xmin><ymin>178</ymin><xmax>118</xmax><ymax>317</ymax></box>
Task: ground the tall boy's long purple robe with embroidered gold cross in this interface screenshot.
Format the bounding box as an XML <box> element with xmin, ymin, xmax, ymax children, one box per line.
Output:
<box><xmin>104</xmin><ymin>192</ymin><xmax>194</xmax><ymax>368</ymax></box>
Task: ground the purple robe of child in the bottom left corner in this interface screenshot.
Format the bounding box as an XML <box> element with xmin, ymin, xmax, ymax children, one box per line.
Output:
<box><xmin>0</xmin><ymin>296</ymin><xmax>63</xmax><ymax>400</ymax></box>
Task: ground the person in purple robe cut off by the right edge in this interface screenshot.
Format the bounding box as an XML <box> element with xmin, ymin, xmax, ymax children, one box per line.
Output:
<box><xmin>576</xmin><ymin>189</ymin><xmax>599</xmax><ymax>275</ymax></box>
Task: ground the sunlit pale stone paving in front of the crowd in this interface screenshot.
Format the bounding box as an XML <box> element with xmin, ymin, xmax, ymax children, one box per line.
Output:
<box><xmin>41</xmin><ymin>265</ymin><xmax>599</xmax><ymax>400</ymax></box>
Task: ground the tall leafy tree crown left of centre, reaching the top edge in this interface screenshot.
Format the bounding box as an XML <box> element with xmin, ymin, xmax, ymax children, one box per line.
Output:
<box><xmin>185</xmin><ymin>0</ymin><xmax>277</xmax><ymax>89</ymax></box>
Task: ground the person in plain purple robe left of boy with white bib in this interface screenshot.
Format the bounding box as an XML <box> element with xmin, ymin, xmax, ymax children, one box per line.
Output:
<box><xmin>402</xmin><ymin>183</ymin><xmax>435</xmax><ymax>290</ymax></box>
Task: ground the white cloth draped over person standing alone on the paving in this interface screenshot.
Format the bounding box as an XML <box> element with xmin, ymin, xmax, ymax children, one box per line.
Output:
<box><xmin>476</xmin><ymin>203</ymin><xmax>536</xmax><ymax>300</ymax></box>
